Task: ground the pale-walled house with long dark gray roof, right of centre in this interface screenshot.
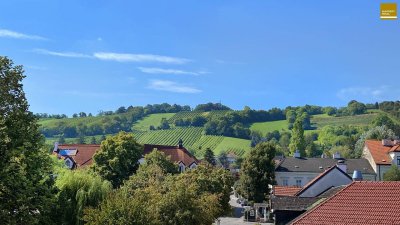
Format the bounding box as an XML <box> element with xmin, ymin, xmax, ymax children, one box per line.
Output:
<box><xmin>275</xmin><ymin>152</ymin><xmax>376</xmax><ymax>187</ymax></box>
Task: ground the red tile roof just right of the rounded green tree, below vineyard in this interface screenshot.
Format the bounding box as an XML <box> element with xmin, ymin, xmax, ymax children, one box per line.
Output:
<box><xmin>143</xmin><ymin>144</ymin><xmax>199</xmax><ymax>166</ymax></box>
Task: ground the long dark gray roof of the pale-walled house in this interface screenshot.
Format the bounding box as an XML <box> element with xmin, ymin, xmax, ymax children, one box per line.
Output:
<box><xmin>275</xmin><ymin>157</ymin><xmax>375</xmax><ymax>174</ymax></box>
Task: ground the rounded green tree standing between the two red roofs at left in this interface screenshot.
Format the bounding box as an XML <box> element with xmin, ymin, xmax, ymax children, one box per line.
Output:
<box><xmin>92</xmin><ymin>131</ymin><xmax>143</xmax><ymax>188</ymax></box>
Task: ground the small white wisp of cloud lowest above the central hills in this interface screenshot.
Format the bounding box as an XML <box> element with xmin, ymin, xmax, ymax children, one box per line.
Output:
<box><xmin>148</xmin><ymin>80</ymin><xmax>201</xmax><ymax>94</ymax></box>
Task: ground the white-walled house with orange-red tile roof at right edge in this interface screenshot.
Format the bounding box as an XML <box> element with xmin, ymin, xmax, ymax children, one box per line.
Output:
<box><xmin>363</xmin><ymin>139</ymin><xmax>400</xmax><ymax>180</ymax></box>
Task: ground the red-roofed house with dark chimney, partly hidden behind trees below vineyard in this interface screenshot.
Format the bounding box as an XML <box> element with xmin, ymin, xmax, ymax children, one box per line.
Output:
<box><xmin>139</xmin><ymin>140</ymin><xmax>200</xmax><ymax>172</ymax></box>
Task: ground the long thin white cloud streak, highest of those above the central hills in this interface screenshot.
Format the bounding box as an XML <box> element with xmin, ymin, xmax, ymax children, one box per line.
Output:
<box><xmin>93</xmin><ymin>52</ymin><xmax>190</xmax><ymax>64</ymax></box>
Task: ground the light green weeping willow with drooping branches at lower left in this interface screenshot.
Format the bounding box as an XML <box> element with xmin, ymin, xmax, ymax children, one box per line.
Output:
<box><xmin>55</xmin><ymin>170</ymin><xmax>112</xmax><ymax>225</ymax></box>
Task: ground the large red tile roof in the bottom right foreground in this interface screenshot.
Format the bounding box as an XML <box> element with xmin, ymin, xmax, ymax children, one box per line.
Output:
<box><xmin>291</xmin><ymin>181</ymin><xmax>400</xmax><ymax>225</ymax></box>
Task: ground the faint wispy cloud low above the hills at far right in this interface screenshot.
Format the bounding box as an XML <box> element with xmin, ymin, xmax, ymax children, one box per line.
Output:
<box><xmin>337</xmin><ymin>85</ymin><xmax>400</xmax><ymax>101</ymax></box>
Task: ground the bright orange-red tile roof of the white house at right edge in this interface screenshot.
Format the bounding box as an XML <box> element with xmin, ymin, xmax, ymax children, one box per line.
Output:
<box><xmin>365</xmin><ymin>140</ymin><xmax>399</xmax><ymax>165</ymax></box>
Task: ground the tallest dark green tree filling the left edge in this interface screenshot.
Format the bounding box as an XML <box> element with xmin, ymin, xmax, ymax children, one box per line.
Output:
<box><xmin>0</xmin><ymin>57</ymin><xmax>54</xmax><ymax>224</ymax></box>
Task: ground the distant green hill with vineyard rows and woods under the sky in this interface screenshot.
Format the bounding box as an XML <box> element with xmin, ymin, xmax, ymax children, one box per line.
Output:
<box><xmin>39</xmin><ymin>102</ymin><xmax>398</xmax><ymax>158</ymax></box>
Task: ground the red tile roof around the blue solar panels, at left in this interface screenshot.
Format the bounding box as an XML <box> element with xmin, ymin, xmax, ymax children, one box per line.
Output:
<box><xmin>58</xmin><ymin>144</ymin><xmax>100</xmax><ymax>167</ymax></box>
